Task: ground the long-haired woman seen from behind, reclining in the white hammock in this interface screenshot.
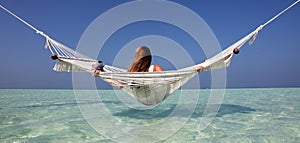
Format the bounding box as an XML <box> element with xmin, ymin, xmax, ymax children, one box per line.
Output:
<box><xmin>94</xmin><ymin>46</ymin><xmax>203</xmax><ymax>76</ymax></box>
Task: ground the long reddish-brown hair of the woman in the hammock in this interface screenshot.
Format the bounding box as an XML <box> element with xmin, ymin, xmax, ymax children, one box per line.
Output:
<box><xmin>128</xmin><ymin>46</ymin><xmax>152</xmax><ymax>72</ymax></box>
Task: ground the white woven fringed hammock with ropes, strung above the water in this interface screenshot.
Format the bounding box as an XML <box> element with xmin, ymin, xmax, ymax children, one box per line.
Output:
<box><xmin>0</xmin><ymin>0</ymin><xmax>300</xmax><ymax>105</ymax></box>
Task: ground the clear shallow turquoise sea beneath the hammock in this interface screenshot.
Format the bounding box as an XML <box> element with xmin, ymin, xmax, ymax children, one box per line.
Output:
<box><xmin>0</xmin><ymin>88</ymin><xmax>300</xmax><ymax>143</ymax></box>
